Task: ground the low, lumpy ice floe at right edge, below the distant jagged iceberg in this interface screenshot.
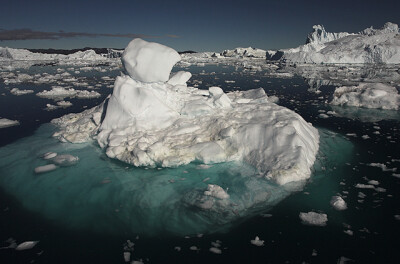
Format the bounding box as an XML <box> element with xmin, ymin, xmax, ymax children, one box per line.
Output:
<box><xmin>331</xmin><ymin>83</ymin><xmax>400</xmax><ymax>110</ymax></box>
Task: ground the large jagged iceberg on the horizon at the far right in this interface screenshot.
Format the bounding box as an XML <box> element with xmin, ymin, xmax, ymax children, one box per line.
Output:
<box><xmin>268</xmin><ymin>22</ymin><xmax>400</xmax><ymax>64</ymax></box>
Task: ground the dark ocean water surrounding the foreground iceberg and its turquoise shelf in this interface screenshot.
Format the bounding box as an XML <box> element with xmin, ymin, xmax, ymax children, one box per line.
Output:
<box><xmin>0</xmin><ymin>65</ymin><xmax>400</xmax><ymax>263</ymax></box>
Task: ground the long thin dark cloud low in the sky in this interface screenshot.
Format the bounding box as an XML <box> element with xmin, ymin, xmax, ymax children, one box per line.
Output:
<box><xmin>0</xmin><ymin>28</ymin><xmax>178</xmax><ymax>41</ymax></box>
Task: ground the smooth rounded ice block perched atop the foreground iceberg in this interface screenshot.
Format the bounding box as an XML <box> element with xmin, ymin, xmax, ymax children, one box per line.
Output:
<box><xmin>122</xmin><ymin>38</ymin><xmax>181</xmax><ymax>82</ymax></box>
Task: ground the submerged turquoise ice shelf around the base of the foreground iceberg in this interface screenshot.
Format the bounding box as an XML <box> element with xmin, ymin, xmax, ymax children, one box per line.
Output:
<box><xmin>0</xmin><ymin>124</ymin><xmax>351</xmax><ymax>235</ymax></box>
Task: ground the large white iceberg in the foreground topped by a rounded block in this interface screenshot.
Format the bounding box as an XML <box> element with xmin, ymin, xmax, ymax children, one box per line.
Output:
<box><xmin>53</xmin><ymin>39</ymin><xmax>319</xmax><ymax>186</ymax></box>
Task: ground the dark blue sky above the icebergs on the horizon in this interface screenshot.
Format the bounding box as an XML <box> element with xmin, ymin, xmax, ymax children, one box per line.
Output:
<box><xmin>0</xmin><ymin>0</ymin><xmax>400</xmax><ymax>52</ymax></box>
